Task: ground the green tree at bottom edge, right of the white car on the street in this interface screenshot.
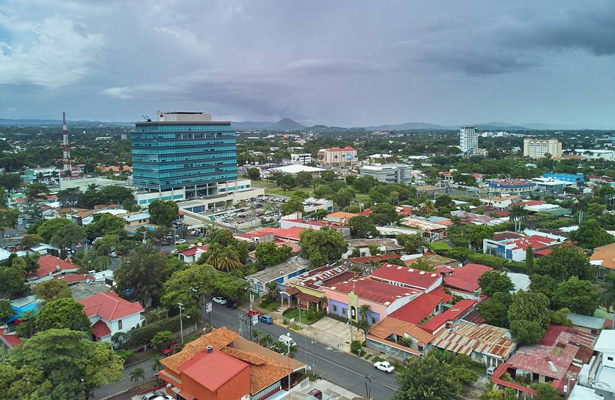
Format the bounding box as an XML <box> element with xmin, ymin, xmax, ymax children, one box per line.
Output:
<box><xmin>394</xmin><ymin>352</ymin><xmax>461</xmax><ymax>400</ymax></box>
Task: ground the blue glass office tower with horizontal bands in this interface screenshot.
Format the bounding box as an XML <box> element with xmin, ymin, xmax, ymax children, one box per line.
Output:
<box><xmin>131</xmin><ymin>112</ymin><xmax>237</xmax><ymax>198</ymax></box>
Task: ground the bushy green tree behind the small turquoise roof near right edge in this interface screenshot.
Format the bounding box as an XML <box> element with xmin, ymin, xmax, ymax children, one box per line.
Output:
<box><xmin>553</xmin><ymin>276</ymin><xmax>601</xmax><ymax>315</ymax></box>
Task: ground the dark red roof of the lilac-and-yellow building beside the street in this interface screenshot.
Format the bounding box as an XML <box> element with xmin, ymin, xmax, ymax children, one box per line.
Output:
<box><xmin>328</xmin><ymin>278</ymin><xmax>421</xmax><ymax>305</ymax></box>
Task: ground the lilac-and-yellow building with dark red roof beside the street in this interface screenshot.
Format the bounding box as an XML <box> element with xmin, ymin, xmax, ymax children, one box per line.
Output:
<box><xmin>323</xmin><ymin>278</ymin><xmax>423</xmax><ymax>325</ymax></box>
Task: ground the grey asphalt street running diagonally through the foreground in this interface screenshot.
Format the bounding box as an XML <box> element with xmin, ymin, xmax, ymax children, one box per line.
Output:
<box><xmin>205</xmin><ymin>303</ymin><xmax>397</xmax><ymax>400</ymax></box>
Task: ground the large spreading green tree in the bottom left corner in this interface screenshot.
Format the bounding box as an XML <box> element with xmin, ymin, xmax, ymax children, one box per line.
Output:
<box><xmin>4</xmin><ymin>329</ymin><xmax>123</xmax><ymax>400</ymax></box>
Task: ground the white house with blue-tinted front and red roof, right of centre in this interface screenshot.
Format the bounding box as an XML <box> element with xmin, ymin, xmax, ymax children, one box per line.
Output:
<box><xmin>483</xmin><ymin>234</ymin><xmax>562</xmax><ymax>262</ymax></box>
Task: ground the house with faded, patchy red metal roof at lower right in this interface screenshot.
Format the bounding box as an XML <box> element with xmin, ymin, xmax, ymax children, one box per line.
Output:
<box><xmin>491</xmin><ymin>326</ymin><xmax>596</xmax><ymax>398</ymax></box>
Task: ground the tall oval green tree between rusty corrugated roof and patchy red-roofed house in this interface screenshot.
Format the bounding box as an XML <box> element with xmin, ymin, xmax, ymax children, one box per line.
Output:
<box><xmin>508</xmin><ymin>290</ymin><xmax>551</xmax><ymax>344</ymax></box>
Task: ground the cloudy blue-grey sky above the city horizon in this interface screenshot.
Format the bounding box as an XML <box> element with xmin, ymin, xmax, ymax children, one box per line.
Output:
<box><xmin>0</xmin><ymin>0</ymin><xmax>615</xmax><ymax>128</ymax></box>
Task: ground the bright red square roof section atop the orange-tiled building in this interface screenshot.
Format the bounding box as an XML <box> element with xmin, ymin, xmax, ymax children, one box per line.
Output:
<box><xmin>179</xmin><ymin>349</ymin><xmax>249</xmax><ymax>392</ymax></box>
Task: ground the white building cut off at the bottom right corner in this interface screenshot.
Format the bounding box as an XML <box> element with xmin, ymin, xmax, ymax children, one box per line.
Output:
<box><xmin>575</xmin><ymin>330</ymin><xmax>615</xmax><ymax>400</ymax></box>
